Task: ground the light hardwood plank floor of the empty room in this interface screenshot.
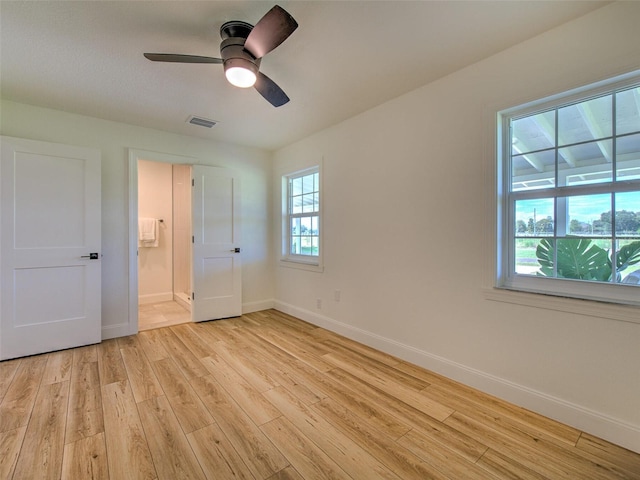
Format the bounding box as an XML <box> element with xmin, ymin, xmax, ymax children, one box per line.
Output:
<box><xmin>0</xmin><ymin>310</ymin><xmax>640</xmax><ymax>480</ymax></box>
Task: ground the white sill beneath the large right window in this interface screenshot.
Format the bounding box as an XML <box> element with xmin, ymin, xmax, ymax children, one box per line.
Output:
<box><xmin>483</xmin><ymin>288</ymin><xmax>640</xmax><ymax>324</ymax></box>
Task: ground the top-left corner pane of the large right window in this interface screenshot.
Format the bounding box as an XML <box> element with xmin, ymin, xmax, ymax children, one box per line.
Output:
<box><xmin>511</xmin><ymin>111</ymin><xmax>556</xmax><ymax>155</ymax></box>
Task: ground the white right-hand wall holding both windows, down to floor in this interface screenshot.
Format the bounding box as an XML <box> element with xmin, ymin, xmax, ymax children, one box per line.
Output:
<box><xmin>274</xmin><ymin>2</ymin><xmax>640</xmax><ymax>451</ymax></box>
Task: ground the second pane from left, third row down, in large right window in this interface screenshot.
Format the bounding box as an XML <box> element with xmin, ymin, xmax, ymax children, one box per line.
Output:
<box><xmin>566</xmin><ymin>193</ymin><xmax>611</xmax><ymax>236</ymax></box>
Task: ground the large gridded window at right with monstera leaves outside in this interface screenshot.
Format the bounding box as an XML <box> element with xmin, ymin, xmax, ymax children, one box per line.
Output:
<box><xmin>498</xmin><ymin>76</ymin><xmax>640</xmax><ymax>304</ymax></box>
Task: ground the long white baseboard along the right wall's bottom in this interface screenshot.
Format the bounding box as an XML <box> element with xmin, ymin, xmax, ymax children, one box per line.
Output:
<box><xmin>273</xmin><ymin>301</ymin><xmax>640</xmax><ymax>453</ymax></box>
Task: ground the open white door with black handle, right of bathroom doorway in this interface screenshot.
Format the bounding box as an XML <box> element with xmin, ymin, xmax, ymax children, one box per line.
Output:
<box><xmin>191</xmin><ymin>165</ymin><xmax>242</xmax><ymax>322</ymax></box>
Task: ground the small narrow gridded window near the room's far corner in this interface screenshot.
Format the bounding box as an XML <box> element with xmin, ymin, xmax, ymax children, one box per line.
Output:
<box><xmin>284</xmin><ymin>167</ymin><xmax>321</xmax><ymax>264</ymax></box>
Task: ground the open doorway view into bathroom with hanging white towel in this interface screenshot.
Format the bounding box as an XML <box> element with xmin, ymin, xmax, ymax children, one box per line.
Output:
<box><xmin>137</xmin><ymin>159</ymin><xmax>191</xmax><ymax>330</ymax></box>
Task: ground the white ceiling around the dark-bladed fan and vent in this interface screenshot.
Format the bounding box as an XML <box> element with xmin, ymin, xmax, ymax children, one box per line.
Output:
<box><xmin>0</xmin><ymin>0</ymin><xmax>609</xmax><ymax>150</ymax></box>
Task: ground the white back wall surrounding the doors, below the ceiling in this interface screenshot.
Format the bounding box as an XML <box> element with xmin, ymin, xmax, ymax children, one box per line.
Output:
<box><xmin>0</xmin><ymin>100</ymin><xmax>274</xmax><ymax>338</ymax></box>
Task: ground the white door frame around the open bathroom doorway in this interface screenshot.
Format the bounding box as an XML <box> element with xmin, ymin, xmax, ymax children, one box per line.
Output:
<box><xmin>122</xmin><ymin>148</ymin><xmax>198</xmax><ymax>336</ymax></box>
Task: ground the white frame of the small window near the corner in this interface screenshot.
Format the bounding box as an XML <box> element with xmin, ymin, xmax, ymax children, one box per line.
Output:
<box><xmin>280</xmin><ymin>164</ymin><xmax>324</xmax><ymax>272</ymax></box>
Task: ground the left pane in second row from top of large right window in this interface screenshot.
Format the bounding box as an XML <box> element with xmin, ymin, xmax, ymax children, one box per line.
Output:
<box><xmin>511</xmin><ymin>150</ymin><xmax>556</xmax><ymax>192</ymax></box>
